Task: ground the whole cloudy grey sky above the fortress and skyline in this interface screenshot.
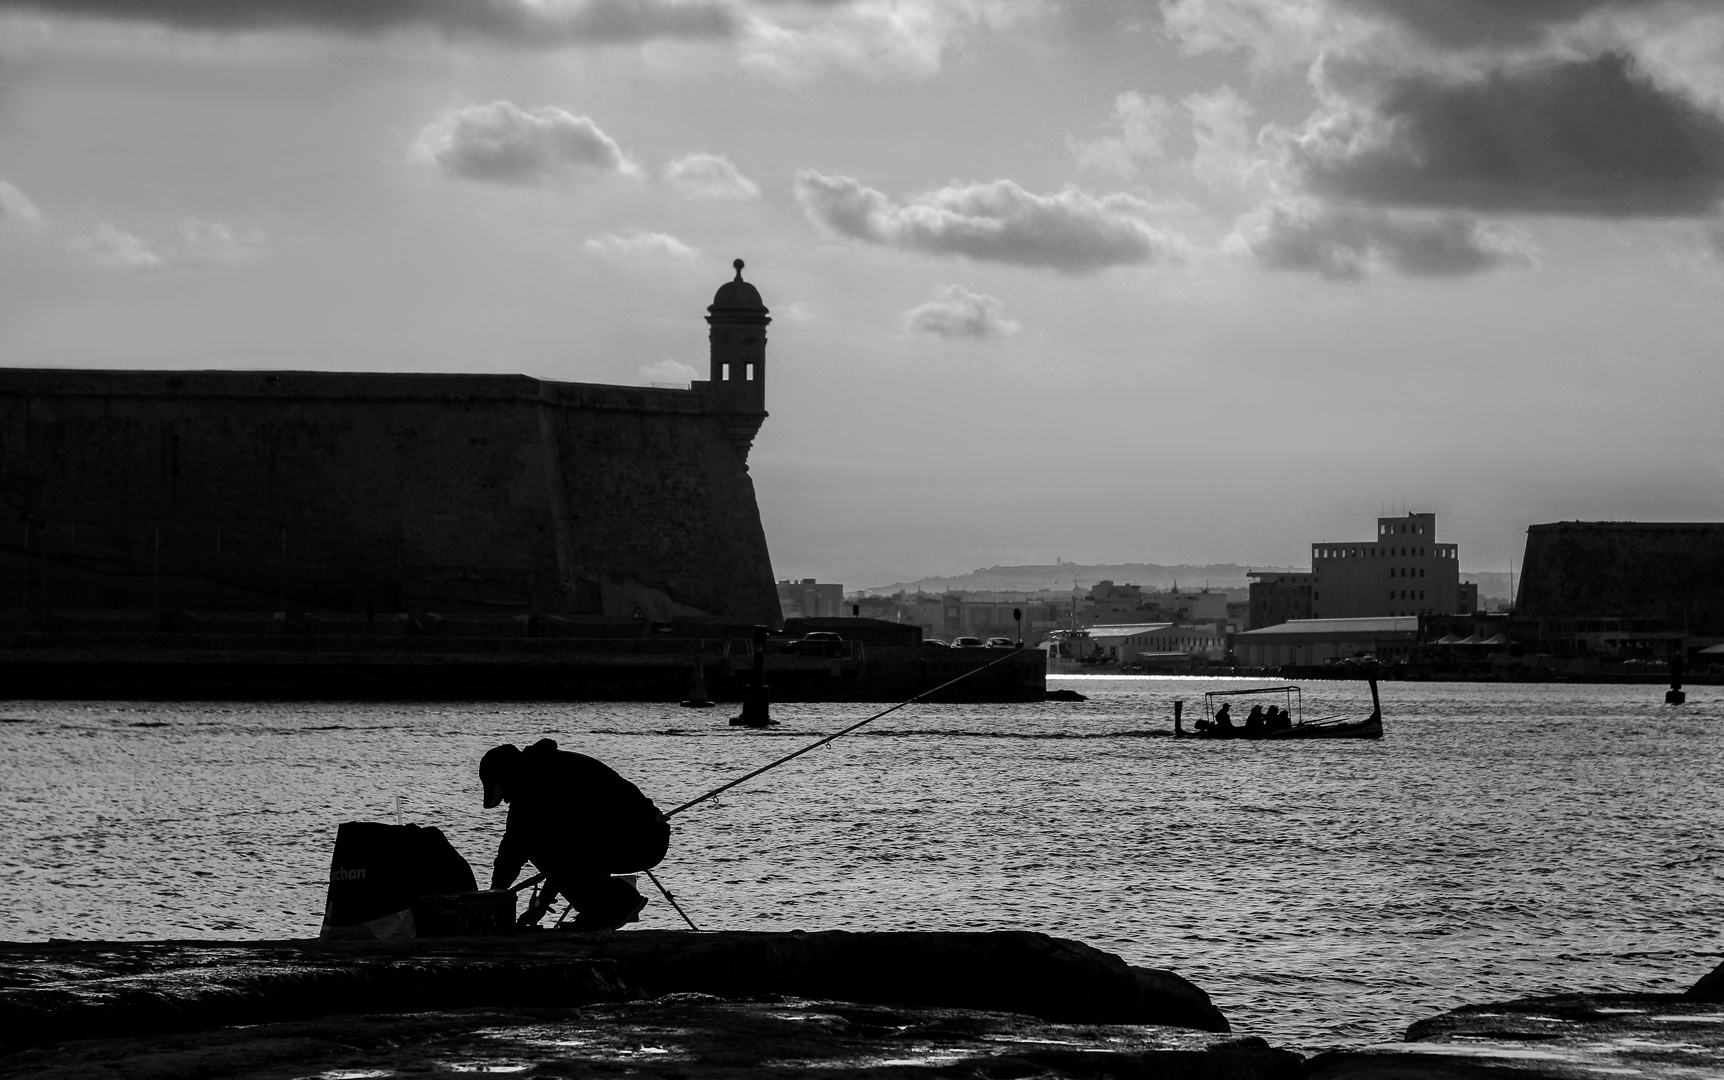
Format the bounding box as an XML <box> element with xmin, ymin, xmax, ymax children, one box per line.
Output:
<box><xmin>0</xmin><ymin>0</ymin><xmax>1724</xmax><ymax>587</ymax></box>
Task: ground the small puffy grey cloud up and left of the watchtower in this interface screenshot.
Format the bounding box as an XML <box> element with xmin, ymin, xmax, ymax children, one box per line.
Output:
<box><xmin>414</xmin><ymin>102</ymin><xmax>640</xmax><ymax>185</ymax></box>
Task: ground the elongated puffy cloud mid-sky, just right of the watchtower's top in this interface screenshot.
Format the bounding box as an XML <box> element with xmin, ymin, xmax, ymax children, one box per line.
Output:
<box><xmin>795</xmin><ymin>169</ymin><xmax>1176</xmax><ymax>273</ymax></box>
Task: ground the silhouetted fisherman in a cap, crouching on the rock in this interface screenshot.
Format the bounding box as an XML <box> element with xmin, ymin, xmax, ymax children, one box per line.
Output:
<box><xmin>479</xmin><ymin>738</ymin><xmax>671</xmax><ymax>930</ymax></box>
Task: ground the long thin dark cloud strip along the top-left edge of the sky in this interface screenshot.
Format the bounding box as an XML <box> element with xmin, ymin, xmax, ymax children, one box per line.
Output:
<box><xmin>0</xmin><ymin>0</ymin><xmax>736</xmax><ymax>45</ymax></box>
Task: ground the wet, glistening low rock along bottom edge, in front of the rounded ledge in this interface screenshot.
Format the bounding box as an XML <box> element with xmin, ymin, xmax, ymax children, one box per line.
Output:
<box><xmin>0</xmin><ymin>994</ymin><xmax>1302</xmax><ymax>1080</ymax></box>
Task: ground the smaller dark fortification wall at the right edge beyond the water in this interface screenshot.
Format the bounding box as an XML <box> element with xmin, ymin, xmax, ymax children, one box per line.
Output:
<box><xmin>1515</xmin><ymin>521</ymin><xmax>1724</xmax><ymax>633</ymax></box>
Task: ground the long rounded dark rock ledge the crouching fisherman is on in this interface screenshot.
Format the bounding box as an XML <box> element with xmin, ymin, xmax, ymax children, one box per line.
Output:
<box><xmin>0</xmin><ymin>930</ymin><xmax>1227</xmax><ymax>1049</ymax></box>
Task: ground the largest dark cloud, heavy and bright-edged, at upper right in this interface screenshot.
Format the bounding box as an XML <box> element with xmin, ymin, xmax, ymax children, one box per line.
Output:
<box><xmin>1295</xmin><ymin>53</ymin><xmax>1724</xmax><ymax>217</ymax></box>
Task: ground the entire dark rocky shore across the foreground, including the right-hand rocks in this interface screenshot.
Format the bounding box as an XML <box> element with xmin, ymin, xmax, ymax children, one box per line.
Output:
<box><xmin>0</xmin><ymin>932</ymin><xmax>1724</xmax><ymax>1080</ymax></box>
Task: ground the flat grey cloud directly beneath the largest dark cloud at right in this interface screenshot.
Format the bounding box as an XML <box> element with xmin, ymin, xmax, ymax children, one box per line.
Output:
<box><xmin>1229</xmin><ymin>200</ymin><xmax>1534</xmax><ymax>281</ymax></box>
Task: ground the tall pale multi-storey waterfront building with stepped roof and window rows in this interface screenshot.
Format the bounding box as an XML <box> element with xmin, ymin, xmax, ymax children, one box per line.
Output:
<box><xmin>1310</xmin><ymin>514</ymin><xmax>1460</xmax><ymax>619</ymax></box>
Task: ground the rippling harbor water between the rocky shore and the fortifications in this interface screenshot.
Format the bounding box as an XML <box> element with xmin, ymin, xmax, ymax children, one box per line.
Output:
<box><xmin>0</xmin><ymin>676</ymin><xmax>1724</xmax><ymax>1047</ymax></box>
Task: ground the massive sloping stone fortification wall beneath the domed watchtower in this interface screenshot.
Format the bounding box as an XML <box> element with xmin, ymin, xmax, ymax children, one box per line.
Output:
<box><xmin>0</xmin><ymin>369</ymin><xmax>779</xmax><ymax>625</ymax></box>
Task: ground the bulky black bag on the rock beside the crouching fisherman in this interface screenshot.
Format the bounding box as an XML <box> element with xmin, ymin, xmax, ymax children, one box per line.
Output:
<box><xmin>321</xmin><ymin>821</ymin><xmax>478</xmax><ymax>940</ymax></box>
